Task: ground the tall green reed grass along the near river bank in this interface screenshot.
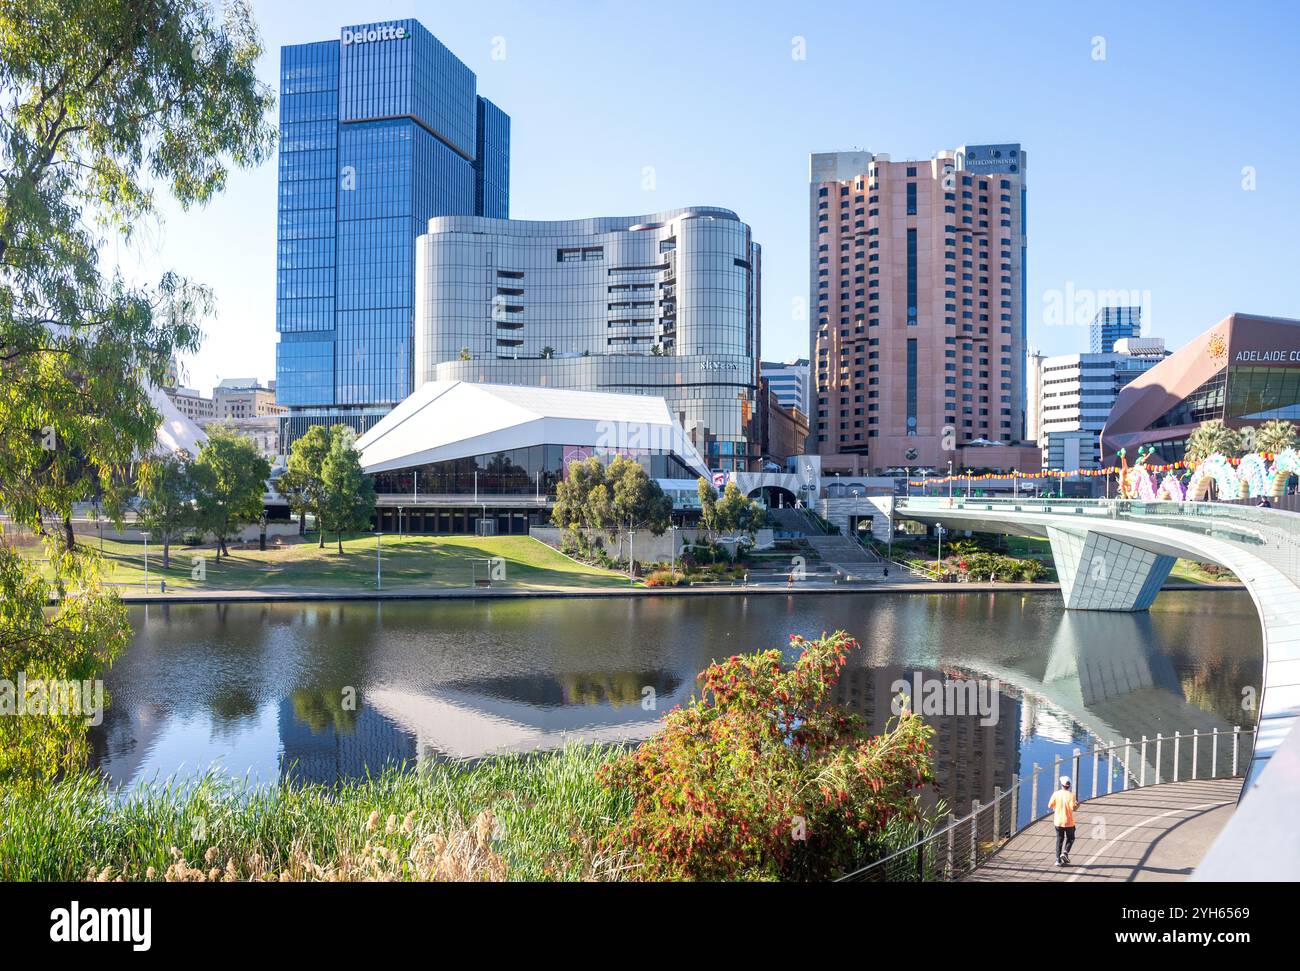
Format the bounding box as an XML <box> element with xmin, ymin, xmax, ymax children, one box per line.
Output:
<box><xmin>0</xmin><ymin>745</ymin><xmax>633</xmax><ymax>881</ymax></box>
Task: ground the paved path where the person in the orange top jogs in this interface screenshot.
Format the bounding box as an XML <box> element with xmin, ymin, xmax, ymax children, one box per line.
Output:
<box><xmin>966</xmin><ymin>779</ymin><xmax>1242</xmax><ymax>883</ymax></box>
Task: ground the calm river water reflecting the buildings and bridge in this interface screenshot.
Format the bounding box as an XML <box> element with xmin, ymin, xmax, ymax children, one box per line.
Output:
<box><xmin>94</xmin><ymin>593</ymin><xmax>1261</xmax><ymax>821</ymax></box>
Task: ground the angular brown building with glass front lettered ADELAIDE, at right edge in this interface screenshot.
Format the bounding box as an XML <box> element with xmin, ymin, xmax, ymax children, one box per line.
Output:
<box><xmin>1101</xmin><ymin>313</ymin><xmax>1300</xmax><ymax>463</ymax></box>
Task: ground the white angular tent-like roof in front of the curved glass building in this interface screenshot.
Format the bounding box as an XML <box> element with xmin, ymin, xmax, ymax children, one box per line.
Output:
<box><xmin>356</xmin><ymin>381</ymin><xmax>709</xmax><ymax>476</ymax></box>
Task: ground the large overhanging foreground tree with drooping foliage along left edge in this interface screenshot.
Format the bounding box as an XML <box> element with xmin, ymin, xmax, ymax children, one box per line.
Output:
<box><xmin>0</xmin><ymin>0</ymin><xmax>274</xmax><ymax>785</ymax></box>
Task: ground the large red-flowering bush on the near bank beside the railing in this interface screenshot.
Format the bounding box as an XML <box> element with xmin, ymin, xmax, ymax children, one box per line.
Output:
<box><xmin>599</xmin><ymin>632</ymin><xmax>933</xmax><ymax>880</ymax></box>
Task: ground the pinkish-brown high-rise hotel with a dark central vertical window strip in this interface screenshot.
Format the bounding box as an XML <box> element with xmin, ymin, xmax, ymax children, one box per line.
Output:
<box><xmin>809</xmin><ymin>144</ymin><xmax>1026</xmax><ymax>472</ymax></box>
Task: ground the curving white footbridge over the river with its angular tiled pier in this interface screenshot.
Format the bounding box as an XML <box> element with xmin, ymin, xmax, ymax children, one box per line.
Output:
<box><xmin>893</xmin><ymin>497</ymin><xmax>1300</xmax><ymax>789</ymax></box>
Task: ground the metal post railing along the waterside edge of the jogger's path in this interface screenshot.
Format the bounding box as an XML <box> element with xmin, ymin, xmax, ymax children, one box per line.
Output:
<box><xmin>840</xmin><ymin>725</ymin><xmax>1256</xmax><ymax>883</ymax></box>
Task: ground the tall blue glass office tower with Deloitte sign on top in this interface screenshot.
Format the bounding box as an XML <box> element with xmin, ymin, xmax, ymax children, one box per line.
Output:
<box><xmin>276</xmin><ymin>19</ymin><xmax>510</xmax><ymax>448</ymax></box>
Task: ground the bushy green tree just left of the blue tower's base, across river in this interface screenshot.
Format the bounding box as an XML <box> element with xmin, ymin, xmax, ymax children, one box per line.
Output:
<box><xmin>192</xmin><ymin>426</ymin><xmax>270</xmax><ymax>560</ymax></box>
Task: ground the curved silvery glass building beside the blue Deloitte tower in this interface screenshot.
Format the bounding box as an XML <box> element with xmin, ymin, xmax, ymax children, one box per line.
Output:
<box><xmin>412</xmin><ymin>207</ymin><xmax>762</xmax><ymax>471</ymax></box>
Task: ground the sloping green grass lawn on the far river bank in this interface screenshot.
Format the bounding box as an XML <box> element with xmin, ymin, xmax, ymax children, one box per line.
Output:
<box><xmin>25</xmin><ymin>534</ymin><xmax>628</xmax><ymax>591</ymax></box>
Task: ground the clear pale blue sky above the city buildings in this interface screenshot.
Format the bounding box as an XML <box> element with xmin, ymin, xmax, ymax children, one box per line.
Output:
<box><xmin>122</xmin><ymin>0</ymin><xmax>1300</xmax><ymax>390</ymax></box>
